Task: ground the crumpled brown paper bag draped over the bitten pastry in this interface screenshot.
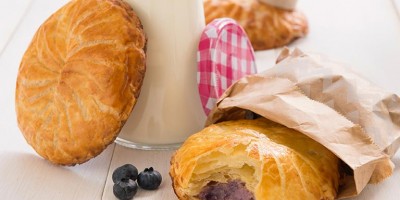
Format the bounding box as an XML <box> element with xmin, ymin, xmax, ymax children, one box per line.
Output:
<box><xmin>206</xmin><ymin>49</ymin><xmax>400</xmax><ymax>198</ymax></box>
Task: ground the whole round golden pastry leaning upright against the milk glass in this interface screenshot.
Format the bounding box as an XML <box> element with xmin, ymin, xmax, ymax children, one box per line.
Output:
<box><xmin>15</xmin><ymin>0</ymin><xmax>146</xmax><ymax>165</ymax></box>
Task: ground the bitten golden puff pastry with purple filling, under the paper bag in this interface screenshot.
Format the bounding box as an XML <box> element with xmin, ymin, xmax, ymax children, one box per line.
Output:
<box><xmin>170</xmin><ymin>119</ymin><xmax>339</xmax><ymax>200</ymax></box>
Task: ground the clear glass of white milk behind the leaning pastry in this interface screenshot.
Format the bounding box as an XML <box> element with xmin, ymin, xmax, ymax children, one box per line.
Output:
<box><xmin>117</xmin><ymin>0</ymin><xmax>206</xmax><ymax>149</ymax></box>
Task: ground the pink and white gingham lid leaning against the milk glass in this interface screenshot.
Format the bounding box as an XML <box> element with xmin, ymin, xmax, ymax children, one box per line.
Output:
<box><xmin>197</xmin><ymin>18</ymin><xmax>257</xmax><ymax>115</ymax></box>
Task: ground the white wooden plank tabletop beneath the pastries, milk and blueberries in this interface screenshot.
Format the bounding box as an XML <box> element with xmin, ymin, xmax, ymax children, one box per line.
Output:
<box><xmin>0</xmin><ymin>0</ymin><xmax>400</xmax><ymax>200</ymax></box>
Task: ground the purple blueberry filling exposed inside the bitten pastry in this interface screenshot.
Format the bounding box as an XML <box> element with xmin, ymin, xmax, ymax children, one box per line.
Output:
<box><xmin>198</xmin><ymin>180</ymin><xmax>255</xmax><ymax>200</ymax></box>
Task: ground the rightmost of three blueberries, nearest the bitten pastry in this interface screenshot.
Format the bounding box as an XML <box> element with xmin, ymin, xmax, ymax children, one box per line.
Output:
<box><xmin>137</xmin><ymin>167</ymin><xmax>162</xmax><ymax>190</ymax></box>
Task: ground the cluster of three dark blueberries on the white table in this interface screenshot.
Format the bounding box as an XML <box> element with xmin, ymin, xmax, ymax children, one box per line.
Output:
<box><xmin>112</xmin><ymin>164</ymin><xmax>162</xmax><ymax>200</ymax></box>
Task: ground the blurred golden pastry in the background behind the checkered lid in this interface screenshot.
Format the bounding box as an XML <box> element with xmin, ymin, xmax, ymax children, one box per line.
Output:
<box><xmin>204</xmin><ymin>0</ymin><xmax>308</xmax><ymax>50</ymax></box>
